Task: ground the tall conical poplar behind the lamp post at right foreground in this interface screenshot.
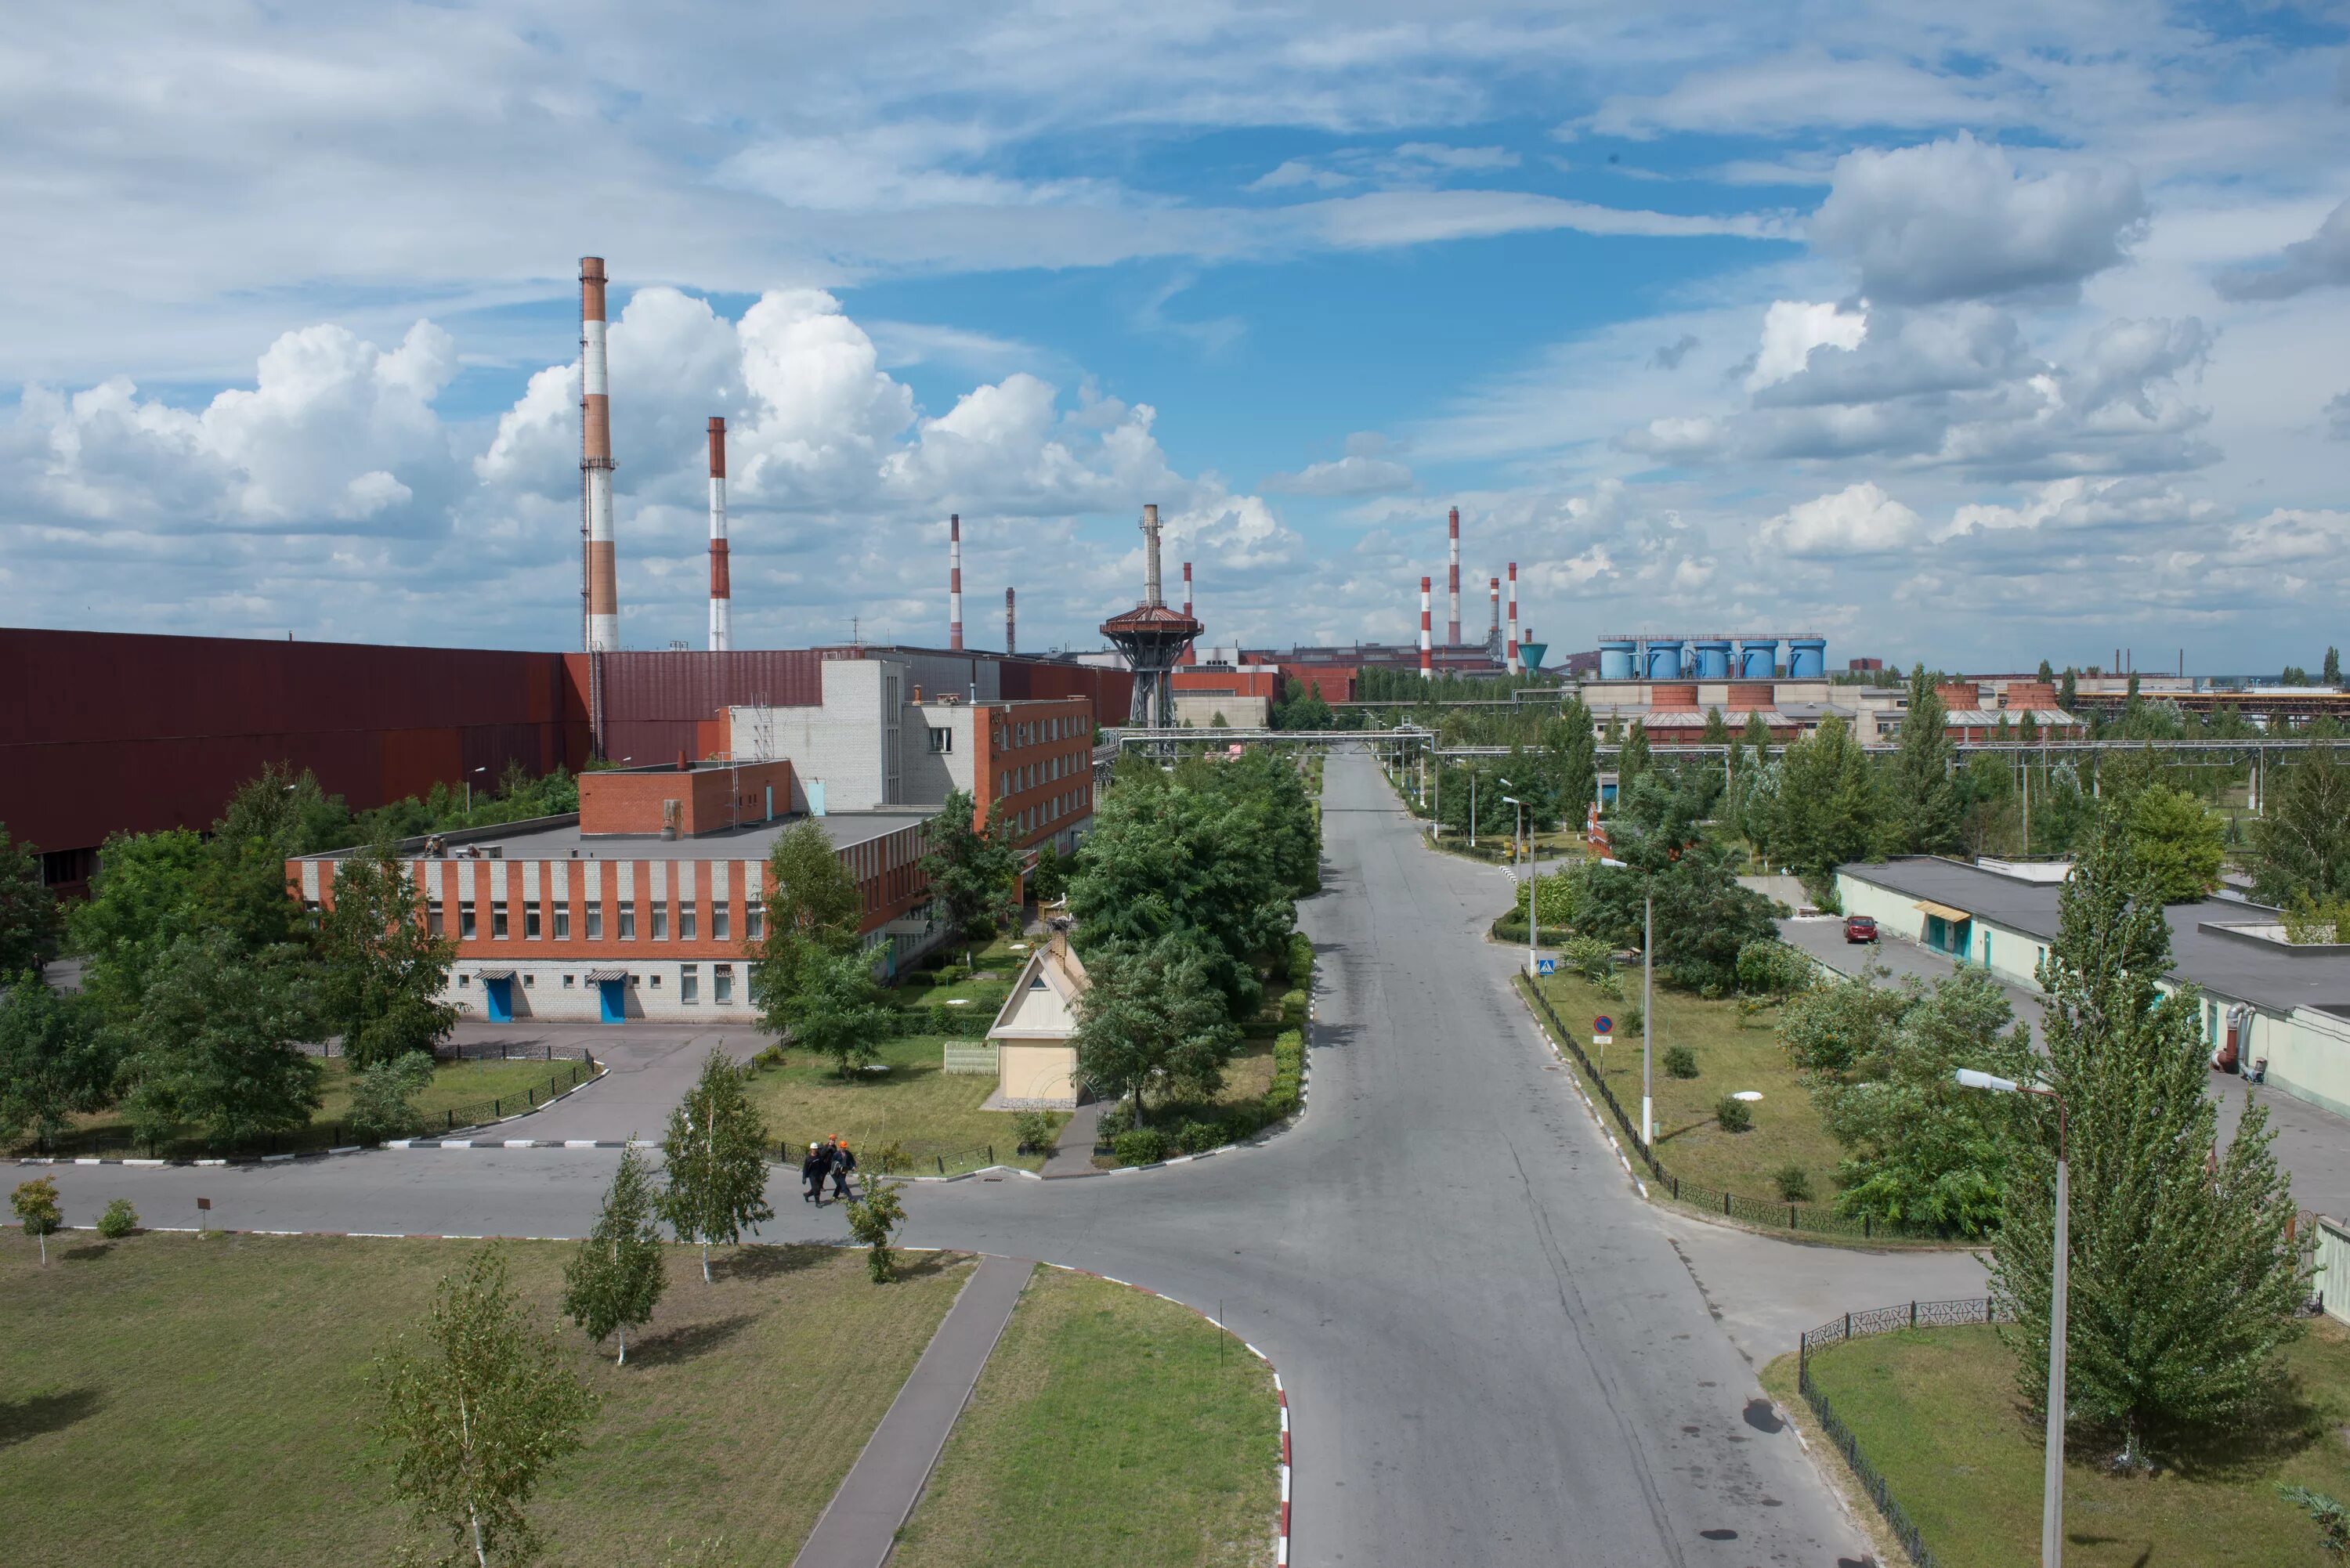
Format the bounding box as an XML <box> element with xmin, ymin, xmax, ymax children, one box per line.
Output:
<box><xmin>1993</xmin><ymin>809</ymin><xmax>2305</xmax><ymax>1465</ymax></box>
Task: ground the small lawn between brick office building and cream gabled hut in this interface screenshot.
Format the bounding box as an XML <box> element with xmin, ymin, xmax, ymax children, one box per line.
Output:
<box><xmin>750</xmin><ymin>1035</ymin><xmax>1043</xmax><ymax>1173</ymax></box>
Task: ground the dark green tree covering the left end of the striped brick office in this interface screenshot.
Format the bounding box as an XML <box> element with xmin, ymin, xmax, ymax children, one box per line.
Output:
<box><xmin>317</xmin><ymin>842</ymin><xmax>458</xmax><ymax>1068</ymax></box>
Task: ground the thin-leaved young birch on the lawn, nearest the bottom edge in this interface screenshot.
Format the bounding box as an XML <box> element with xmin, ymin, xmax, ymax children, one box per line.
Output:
<box><xmin>371</xmin><ymin>1248</ymin><xmax>597</xmax><ymax>1568</ymax></box>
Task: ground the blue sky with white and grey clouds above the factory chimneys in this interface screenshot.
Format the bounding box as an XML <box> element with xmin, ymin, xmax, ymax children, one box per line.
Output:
<box><xmin>0</xmin><ymin>0</ymin><xmax>2350</xmax><ymax>674</ymax></box>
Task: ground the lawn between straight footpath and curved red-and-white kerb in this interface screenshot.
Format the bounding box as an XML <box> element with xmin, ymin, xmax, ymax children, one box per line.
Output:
<box><xmin>891</xmin><ymin>1267</ymin><xmax>1281</xmax><ymax>1568</ymax></box>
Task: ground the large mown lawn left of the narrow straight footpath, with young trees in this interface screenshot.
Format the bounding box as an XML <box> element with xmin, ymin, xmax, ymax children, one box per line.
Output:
<box><xmin>0</xmin><ymin>1232</ymin><xmax>968</xmax><ymax>1568</ymax></box>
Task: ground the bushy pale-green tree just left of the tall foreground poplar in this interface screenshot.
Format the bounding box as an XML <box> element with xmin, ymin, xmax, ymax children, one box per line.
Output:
<box><xmin>1807</xmin><ymin>969</ymin><xmax>2037</xmax><ymax>1237</ymax></box>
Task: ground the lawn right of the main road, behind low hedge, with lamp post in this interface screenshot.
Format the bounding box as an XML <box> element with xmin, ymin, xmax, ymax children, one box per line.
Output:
<box><xmin>1537</xmin><ymin>969</ymin><xmax>1840</xmax><ymax>1204</ymax></box>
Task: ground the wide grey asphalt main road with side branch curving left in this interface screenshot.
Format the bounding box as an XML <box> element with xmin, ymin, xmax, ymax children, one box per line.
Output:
<box><xmin>45</xmin><ymin>754</ymin><xmax>1866</xmax><ymax>1568</ymax></box>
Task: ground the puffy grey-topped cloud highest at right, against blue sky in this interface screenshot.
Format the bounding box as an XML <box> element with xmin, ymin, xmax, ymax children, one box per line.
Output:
<box><xmin>1812</xmin><ymin>132</ymin><xmax>2146</xmax><ymax>305</ymax></box>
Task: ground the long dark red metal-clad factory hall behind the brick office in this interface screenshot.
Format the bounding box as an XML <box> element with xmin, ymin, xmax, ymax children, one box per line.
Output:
<box><xmin>0</xmin><ymin>627</ymin><xmax>1133</xmax><ymax>896</ymax></box>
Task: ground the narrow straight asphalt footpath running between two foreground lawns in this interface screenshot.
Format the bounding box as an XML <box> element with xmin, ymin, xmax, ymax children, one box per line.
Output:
<box><xmin>792</xmin><ymin>1255</ymin><xmax>1036</xmax><ymax>1568</ymax></box>
